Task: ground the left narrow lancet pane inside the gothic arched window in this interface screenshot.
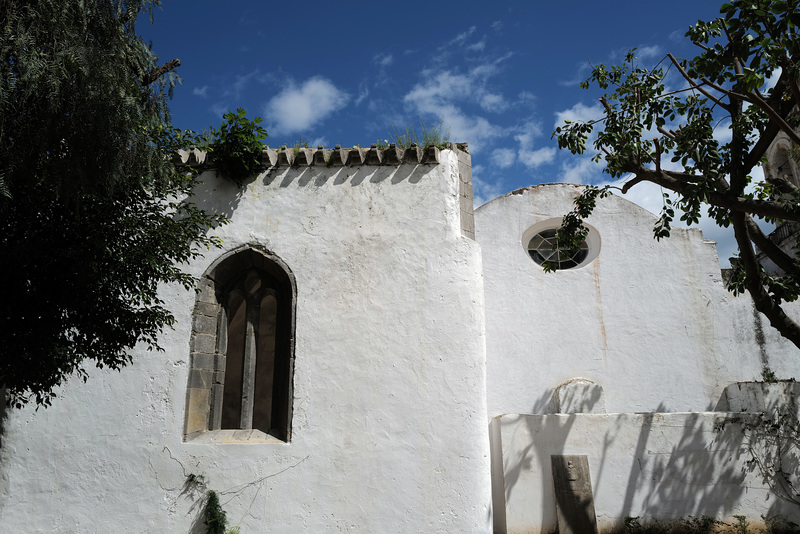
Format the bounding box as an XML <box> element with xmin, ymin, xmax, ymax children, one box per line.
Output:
<box><xmin>221</xmin><ymin>291</ymin><xmax>247</xmax><ymax>428</ymax></box>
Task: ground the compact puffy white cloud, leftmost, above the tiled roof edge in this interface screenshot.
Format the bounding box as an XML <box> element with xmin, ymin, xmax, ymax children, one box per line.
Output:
<box><xmin>264</xmin><ymin>76</ymin><xmax>350</xmax><ymax>135</ymax></box>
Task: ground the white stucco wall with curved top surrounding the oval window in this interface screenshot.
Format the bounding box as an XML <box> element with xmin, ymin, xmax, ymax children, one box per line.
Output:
<box><xmin>475</xmin><ymin>184</ymin><xmax>800</xmax><ymax>416</ymax></box>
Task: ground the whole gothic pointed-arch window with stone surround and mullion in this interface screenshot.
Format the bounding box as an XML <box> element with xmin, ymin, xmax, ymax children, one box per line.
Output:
<box><xmin>184</xmin><ymin>247</ymin><xmax>295</xmax><ymax>441</ymax></box>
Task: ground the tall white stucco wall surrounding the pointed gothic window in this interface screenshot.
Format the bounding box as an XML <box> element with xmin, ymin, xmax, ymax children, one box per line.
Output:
<box><xmin>0</xmin><ymin>151</ymin><xmax>491</xmax><ymax>533</ymax></box>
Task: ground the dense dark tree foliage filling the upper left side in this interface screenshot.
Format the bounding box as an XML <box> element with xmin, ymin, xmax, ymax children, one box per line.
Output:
<box><xmin>0</xmin><ymin>0</ymin><xmax>228</xmax><ymax>406</ymax></box>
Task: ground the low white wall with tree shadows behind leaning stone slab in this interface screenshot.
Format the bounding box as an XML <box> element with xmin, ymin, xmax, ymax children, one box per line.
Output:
<box><xmin>492</xmin><ymin>412</ymin><xmax>800</xmax><ymax>534</ymax></box>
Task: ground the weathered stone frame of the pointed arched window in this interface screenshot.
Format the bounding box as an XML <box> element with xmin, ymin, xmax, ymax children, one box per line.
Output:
<box><xmin>183</xmin><ymin>244</ymin><xmax>297</xmax><ymax>443</ymax></box>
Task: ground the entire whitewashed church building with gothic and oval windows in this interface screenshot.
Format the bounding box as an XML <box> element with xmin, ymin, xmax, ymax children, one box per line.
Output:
<box><xmin>0</xmin><ymin>145</ymin><xmax>800</xmax><ymax>534</ymax></box>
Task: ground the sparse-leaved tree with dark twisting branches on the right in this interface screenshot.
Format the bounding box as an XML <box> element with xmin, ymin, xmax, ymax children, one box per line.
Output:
<box><xmin>553</xmin><ymin>0</ymin><xmax>800</xmax><ymax>347</ymax></box>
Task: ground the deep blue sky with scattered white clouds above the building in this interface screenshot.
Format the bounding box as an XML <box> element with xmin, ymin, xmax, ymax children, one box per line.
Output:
<box><xmin>138</xmin><ymin>0</ymin><xmax>744</xmax><ymax>263</ymax></box>
